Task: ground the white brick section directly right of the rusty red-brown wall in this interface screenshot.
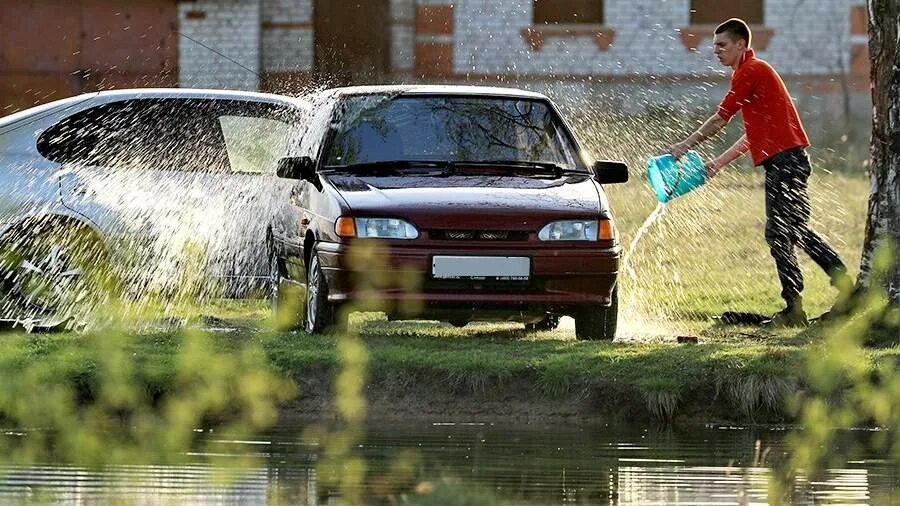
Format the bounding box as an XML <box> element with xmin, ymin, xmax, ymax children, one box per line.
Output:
<box><xmin>178</xmin><ymin>0</ymin><xmax>260</xmax><ymax>90</ymax></box>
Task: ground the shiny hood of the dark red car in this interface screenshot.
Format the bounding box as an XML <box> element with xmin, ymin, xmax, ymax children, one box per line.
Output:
<box><xmin>327</xmin><ymin>174</ymin><xmax>607</xmax><ymax>231</ymax></box>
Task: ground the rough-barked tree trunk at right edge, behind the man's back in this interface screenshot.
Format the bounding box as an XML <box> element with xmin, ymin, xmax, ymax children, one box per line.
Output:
<box><xmin>859</xmin><ymin>0</ymin><xmax>900</xmax><ymax>303</ymax></box>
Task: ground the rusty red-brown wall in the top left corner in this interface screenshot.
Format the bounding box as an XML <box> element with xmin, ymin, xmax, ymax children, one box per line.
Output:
<box><xmin>0</xmin><ymin>0</ymin><xmax>178</xmax><ymax>116</ymax></box>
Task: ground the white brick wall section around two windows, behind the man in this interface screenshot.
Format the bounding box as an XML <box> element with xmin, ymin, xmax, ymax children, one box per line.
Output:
<box><xmin>458</xmin><ymin>0</ymin><xmax>857</xmax><ymax>76</ymax></box>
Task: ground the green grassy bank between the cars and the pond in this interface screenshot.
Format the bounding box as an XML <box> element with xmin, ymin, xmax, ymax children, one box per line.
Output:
<box><xmin>0</xmin><ymin>302</ymin><xmax>900</xmax><ymax>422</ymax></box>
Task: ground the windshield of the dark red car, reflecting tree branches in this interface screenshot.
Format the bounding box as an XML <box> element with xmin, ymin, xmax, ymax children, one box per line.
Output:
<box><xmin>325</xmin><ymin>95</ymin><xmax>580</xmax><ymax>169</ymax></box>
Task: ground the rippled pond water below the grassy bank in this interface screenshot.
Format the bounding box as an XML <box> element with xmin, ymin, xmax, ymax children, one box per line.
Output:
<box><xmin>0</xmin><ymin>423</ymin><xmax>898</xmax><ymax>505</ymax></box>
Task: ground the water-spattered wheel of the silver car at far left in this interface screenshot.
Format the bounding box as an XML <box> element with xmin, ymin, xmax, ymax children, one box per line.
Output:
<box><xmin>0</xmin><ymin>222</ymin><xmax>119</xmax><ymax>330</ymax></box>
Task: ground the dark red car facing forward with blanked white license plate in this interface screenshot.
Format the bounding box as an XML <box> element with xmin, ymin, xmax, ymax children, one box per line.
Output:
<box><xmin>269</xmin><ymin>86</ymin><xmax>628</xmax><ymax>339</ymax></box>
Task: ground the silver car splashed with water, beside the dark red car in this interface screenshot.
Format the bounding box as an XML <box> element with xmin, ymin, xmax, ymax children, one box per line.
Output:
<box><xmin>0</xmin><ymin>89</ymin><xmax>309</xmax><ymax>326</ymax></box>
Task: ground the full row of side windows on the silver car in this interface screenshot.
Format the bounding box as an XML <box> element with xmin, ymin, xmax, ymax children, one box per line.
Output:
<box><xmin>38</xmin><ymin>98</ymin><xmax>302</xmax><ymax>172</ymax></box>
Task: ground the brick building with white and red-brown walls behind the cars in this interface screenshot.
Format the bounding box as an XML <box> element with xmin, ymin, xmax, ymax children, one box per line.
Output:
<box><xmin>0</xmin><ymin>0</ymin><xmax>868</xmax><ymax>115</ymax></box>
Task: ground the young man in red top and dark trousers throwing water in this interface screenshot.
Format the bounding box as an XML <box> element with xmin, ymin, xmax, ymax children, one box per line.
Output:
<box><xmin>670</xmin><ymin>18</ymin><xmax>853</xmax><ymax>326</ymax></box>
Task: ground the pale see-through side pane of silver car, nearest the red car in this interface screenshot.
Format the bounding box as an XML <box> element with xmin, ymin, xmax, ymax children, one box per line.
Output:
<box><xmin>219</xmin><ymin>116</ymin><xmax>292</xmax><ymax>172</ymax></box>
